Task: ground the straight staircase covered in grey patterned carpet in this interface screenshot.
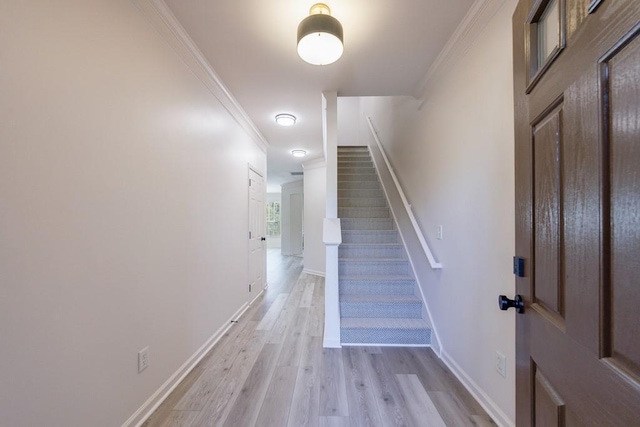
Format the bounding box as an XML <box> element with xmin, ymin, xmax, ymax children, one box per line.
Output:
<box><xmin>338</xmin><ymin>147</ymin><xmax>431</xmax><ymax>346</ymax></box>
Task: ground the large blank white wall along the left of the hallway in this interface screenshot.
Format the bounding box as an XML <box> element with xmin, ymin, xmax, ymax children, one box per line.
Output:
<box><xmin>0</xmin><ymin>0</ymin><xmax>266</xmax><ymax>427</ymax></box>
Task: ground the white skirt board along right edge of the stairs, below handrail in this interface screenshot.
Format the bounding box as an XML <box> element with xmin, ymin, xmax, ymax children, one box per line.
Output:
<box><xmin>367</xmin><ymin>145</ymin><xmax>442</xmax><ymax>357</ymax></box>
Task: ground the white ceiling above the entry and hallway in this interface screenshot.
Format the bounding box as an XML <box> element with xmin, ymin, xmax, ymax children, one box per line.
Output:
<box><xmin>165</xmin><ymin>0</ymin><xmax>474</xmax><ymax>192</ymax></box>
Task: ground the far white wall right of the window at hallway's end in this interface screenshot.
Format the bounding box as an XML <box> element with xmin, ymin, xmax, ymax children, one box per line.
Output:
<box><xmin>280</xmin><ymin>180</ymin><xmax>304</xmax><ymax>255</ymax></box>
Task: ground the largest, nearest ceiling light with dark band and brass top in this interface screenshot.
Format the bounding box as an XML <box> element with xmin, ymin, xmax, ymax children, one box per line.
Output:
<box><xmin>298</xmin><ymin>3</ymin><xmax>344</xmax><ymax>65</ymax></box>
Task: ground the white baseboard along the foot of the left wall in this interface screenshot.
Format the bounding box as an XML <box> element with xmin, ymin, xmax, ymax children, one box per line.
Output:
<box><xmin>122</xmin><ymin>303</ymin><xmax>250</xmax><ymax>427</ymax></box>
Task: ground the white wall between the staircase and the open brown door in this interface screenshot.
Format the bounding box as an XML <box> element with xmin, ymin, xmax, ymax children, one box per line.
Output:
<box><xmin>361</xmin><ymin>0</ymin><xmax>516</xmax><ymax>423</ymax></box>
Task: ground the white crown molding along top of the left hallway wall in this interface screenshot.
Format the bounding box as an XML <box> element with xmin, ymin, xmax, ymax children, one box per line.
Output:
<box><xmin>131</xmin><ymin>0</ymin><xmax>269</xmax><ymax>153</ymax></box>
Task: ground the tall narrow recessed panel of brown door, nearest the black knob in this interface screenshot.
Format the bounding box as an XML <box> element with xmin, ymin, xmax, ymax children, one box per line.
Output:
<box><xmin>564</xmin><ymin>72</ymin><xmax>604</xmax><ymax>356</ymax></box>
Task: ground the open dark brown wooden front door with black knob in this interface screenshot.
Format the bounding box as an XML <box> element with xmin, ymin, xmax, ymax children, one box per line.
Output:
<box><xmin>513</xmin><ymin>0</ymin><xmax>640</xmax><ymax>427</ymax></box>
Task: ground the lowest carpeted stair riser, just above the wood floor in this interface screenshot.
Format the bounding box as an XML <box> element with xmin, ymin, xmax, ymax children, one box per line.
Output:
<box><xmin>340</xmin><ymin>328</ymin><xmax>431</xmax><ymax>346</ymax></box>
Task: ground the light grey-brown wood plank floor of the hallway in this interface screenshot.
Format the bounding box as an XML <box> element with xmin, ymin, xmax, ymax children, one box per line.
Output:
<box><xmin>143</xmin><ymin>249</ymin><xmax>495</xmax><ymax>427</ymax></box>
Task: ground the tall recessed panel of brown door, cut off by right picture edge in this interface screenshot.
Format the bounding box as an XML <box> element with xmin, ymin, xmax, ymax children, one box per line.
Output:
<box><xmin>603</xmin><ymin>31</ymin><xmax>640</xmax><ymax>378</ymax></box>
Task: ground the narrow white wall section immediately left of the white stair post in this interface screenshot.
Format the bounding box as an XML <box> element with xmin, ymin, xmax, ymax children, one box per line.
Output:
<box><xmin>302</xmin><ymin>158</ymin><xmax>327</xmax><ymax>276</ymax></box>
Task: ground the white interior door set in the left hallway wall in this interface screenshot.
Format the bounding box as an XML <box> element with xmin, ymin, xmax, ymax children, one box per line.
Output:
<box><xmin>249</xmin><ymin>169</ymin><xmax>266</xmax><ymax>301</ymax></box>
